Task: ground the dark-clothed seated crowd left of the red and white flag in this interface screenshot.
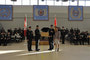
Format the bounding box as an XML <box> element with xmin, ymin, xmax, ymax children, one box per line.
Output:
<box><xmin>0</xmin><ymin>29</ymin><xmax>24</xmax><ymax>46</ymax></box>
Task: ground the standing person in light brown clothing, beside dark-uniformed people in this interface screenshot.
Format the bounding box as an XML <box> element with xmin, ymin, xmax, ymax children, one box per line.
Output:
<box><xmin>54</xmin><ymin>27</ymin><xmax>60</xmax><ymax>51</ymax></box>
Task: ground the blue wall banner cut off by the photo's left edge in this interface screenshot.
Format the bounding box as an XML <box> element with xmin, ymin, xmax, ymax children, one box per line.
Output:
<box><xmin>0</xmin><ymin>5</ymin><xmax>13</xmax><ymax>21</ymax></box>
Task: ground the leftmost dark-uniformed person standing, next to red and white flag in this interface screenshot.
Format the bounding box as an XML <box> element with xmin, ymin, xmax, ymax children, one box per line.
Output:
<box><xmin>27</xmin><ymin>26</ymin><xmax>33</xmax><ymax>51</ymax></box>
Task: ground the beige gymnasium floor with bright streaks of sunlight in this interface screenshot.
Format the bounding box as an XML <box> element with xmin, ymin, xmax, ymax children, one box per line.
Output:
<box><xmin>0</xmin><ymin>42</ymin><xmax>90</xmax><ymax>60</ymax></box>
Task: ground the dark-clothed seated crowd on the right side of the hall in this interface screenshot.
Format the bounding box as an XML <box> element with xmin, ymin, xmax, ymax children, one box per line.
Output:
<box><xmin>61</xmin><ymin>28</ymin><xmax>89</xmax><ymax>45</ymax></box>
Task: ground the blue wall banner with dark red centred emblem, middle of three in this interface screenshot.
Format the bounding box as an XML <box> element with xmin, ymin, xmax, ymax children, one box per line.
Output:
<box><xmin>33</xmin><ymin>5</ymin><xmax>49</xmax><ymax>21</ymax></box>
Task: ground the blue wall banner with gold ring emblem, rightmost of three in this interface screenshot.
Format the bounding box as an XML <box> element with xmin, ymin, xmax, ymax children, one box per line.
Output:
<box><xmin>68</xmin><ymin>6</ymin><xmax>83</xmax><ymax>21</ymax></box>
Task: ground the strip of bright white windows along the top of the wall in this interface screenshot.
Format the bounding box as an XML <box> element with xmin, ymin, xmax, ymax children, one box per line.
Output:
<box><xmin>0</xmin><ymin>0</ymin><xmax>90</xmax><ymax>6</ymax></box>
